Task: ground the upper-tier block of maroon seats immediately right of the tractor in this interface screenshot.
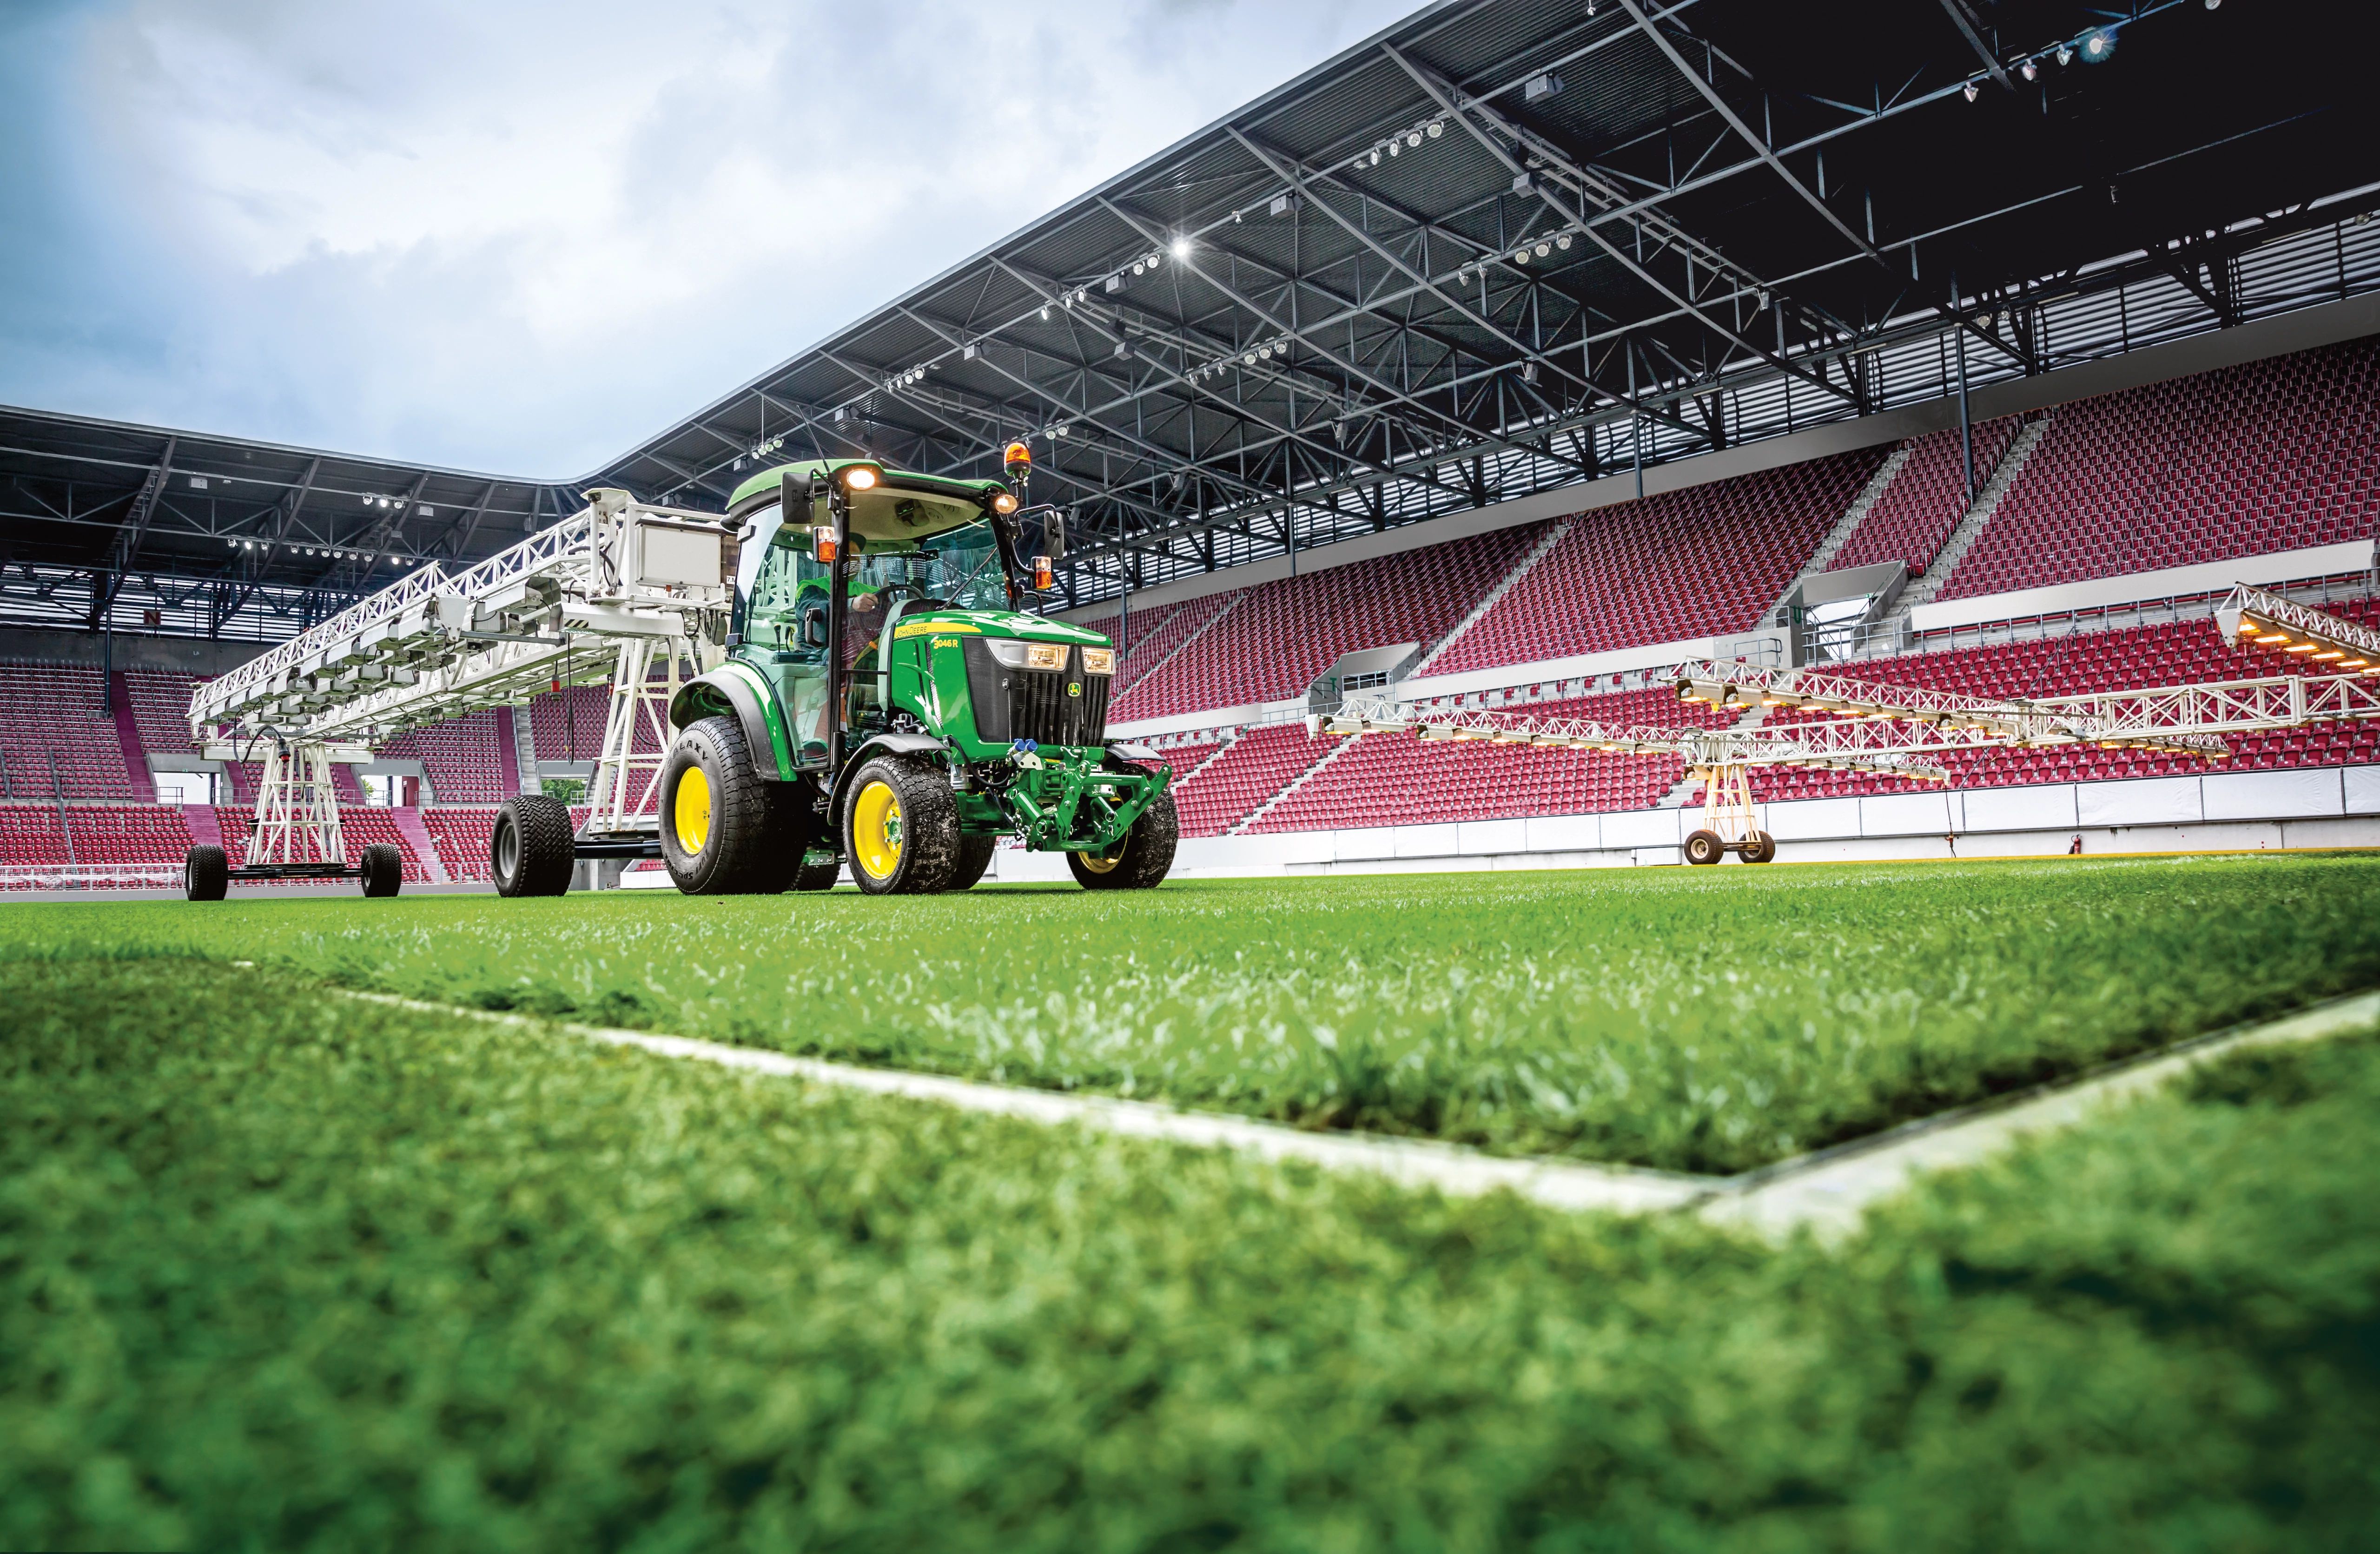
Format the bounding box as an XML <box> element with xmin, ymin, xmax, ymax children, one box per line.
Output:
<box><xmin>1109</xmin><ymin>528</ymin><xmax>1538</xmax><ymax>724</ymax></box>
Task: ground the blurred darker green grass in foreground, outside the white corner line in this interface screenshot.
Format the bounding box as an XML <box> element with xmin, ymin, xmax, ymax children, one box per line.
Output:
<box><xmin>0</xmin><ymin>961</ymin><xmax>2380</xmax><ymax>1554</ymax></box>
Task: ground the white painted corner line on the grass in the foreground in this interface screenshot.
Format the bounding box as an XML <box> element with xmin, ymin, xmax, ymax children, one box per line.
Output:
<box><xmin>340</xmin><ymin>990</ymin><xmax>2380</xmax><ymax>1238</ymax></box>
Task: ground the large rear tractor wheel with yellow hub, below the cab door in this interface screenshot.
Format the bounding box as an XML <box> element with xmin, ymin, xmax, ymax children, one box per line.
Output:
<box><xmin>661</xmin><ymin>714</ymin><xmax>802</xmax><ymax>895</ymax></box>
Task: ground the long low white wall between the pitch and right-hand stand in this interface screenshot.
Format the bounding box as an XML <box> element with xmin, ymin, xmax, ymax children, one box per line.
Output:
<box><xmin>992</xmin><ymin>766</ymin><xmax>2380</xmax><ymax>883</ymax></box>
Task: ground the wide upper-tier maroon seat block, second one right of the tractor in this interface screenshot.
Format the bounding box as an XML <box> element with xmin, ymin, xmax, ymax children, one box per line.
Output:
<box><xmin>1430</xmin><ymin>450</ymin><xmax>1890</xmax><ymax>673</ymax></box>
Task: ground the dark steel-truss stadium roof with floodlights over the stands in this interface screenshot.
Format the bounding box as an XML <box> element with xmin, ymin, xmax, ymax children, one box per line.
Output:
<box><xmin>0</xmin><ymin>0</ymin><xmax>2380</xmax><ymax>635</ymax></box>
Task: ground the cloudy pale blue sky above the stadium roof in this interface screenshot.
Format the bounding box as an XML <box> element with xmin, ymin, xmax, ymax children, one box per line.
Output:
<box><xmin>0</xmin><ymin>0</ymin><xmax>1419</xmax><ymax>478</ymax></box>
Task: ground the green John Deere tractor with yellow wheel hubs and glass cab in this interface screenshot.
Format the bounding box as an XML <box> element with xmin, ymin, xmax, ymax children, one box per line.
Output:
<box><xmin>659</xmin><ymin>445</ymin><xmax>1178</xmax><ymax>895</ymax></box>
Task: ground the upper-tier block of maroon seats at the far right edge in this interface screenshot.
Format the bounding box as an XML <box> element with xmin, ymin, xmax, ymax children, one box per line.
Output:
<box><xmin>1937</xmin><ymin>340</ymin><xmax>2380</xmax><ymax>599</ymax></box>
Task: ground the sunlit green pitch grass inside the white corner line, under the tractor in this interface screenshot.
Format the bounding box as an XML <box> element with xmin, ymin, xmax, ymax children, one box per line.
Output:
<box><xmin>14</xmin><ymin>854</ymin><xmax>2380</xmax><ymax>1171</ymax></box>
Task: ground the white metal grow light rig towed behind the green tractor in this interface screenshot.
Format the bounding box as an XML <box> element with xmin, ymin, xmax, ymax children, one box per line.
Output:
<box><xmin>188</xmin><ymin>488</ymin><xmax>735</xmax><ymax>878</ymax></box>
